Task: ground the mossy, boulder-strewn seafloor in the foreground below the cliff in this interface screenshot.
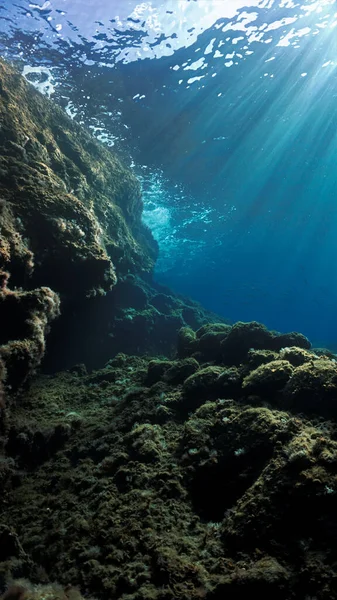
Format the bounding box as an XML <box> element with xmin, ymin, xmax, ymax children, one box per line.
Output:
<box><xmin>0</xmin><ymin>323</ymin><xmax>337</xmax><ymax>600</ymax></box>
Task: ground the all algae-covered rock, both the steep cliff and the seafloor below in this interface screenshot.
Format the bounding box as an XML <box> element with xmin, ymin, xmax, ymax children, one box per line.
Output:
<box><xmin>0</xmin><ymin>61</ymin><xmax>337</xmax><ymax>600</ymax></box>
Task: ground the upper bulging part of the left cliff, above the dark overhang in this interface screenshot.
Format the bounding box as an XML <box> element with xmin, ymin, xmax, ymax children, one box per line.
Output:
<box><xmin>0</xmin><ymin>61</ymin><xmax>157</xmax><ymax>296</ymax></box>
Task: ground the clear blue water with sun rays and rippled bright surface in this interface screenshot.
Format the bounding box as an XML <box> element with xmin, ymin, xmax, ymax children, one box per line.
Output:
<box><xmin>0</xmin><ymin>0</ymin><xmax>337</xmax><ymax>349</ymax></box>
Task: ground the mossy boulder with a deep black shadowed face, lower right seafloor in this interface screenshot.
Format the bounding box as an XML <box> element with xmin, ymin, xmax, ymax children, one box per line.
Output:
<box><xmin>183</xmin><ymin>399</ymin><xmax>289</xmax><ymax>527</ymax></box>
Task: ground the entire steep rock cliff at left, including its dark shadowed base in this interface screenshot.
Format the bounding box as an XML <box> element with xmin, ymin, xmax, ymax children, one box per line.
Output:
<box><xmin>0</xmin><ymin>60</ymin><xmax>220</xmax><ymax>388</ymax></box>
